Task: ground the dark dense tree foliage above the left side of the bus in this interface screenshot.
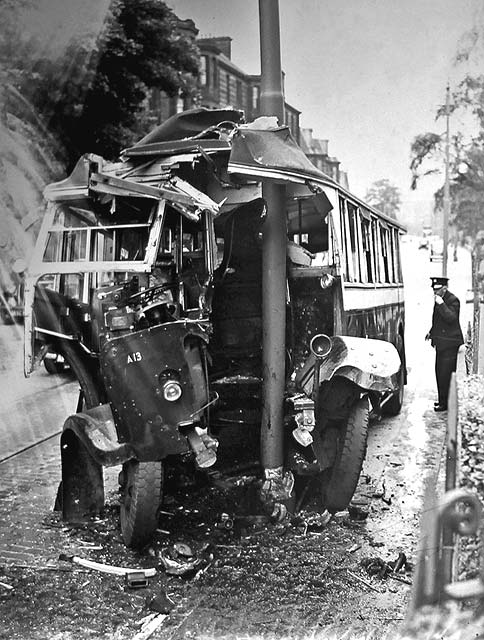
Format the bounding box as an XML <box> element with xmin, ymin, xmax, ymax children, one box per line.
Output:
<box><xmin>0</xmin><ymin>0</ymin><xmax>199</xmax><ymax>166</ymax></box>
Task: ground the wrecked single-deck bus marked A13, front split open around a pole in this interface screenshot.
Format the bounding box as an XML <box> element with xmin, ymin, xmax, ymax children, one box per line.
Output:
<box><xmin>25</xmin><ymin>109</ymin><xmax>406</xmax><ymax>547</ymax></box>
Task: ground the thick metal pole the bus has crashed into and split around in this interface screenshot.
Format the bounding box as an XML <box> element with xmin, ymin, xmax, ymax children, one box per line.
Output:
<box><xmin>259</xmin><ymin>0</ymin><xmax>287</xmax><ymax>474</ymax></box>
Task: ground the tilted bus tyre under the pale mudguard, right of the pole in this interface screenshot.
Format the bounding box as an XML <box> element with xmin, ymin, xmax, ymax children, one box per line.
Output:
<box><xmin>323</xmin><ymin>396</ymin><xmax>369</xmax><ymax>513</ymax></box>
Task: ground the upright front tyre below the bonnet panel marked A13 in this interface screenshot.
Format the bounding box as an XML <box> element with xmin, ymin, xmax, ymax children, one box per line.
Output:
<box><xmin>120</xmin><ymin>460</ymin><xmax>163</xmax><ymax>549</ymax></box>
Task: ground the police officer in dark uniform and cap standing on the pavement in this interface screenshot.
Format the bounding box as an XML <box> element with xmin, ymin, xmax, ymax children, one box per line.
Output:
<box><xmin>425</xmin><ymin>277</ymin><xmax>464</xmax><ymax>411</ymax></box>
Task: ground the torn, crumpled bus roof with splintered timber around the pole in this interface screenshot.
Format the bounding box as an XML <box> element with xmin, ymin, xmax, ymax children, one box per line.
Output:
<box><xmin>44</xmin><ymin>108</ymin><xmax>404</xmax><ymax>229</ymax></box>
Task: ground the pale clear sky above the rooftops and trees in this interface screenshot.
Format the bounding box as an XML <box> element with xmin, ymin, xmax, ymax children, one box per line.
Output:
<box><xmin>165</xmin><ymin>0</ymin><xmax>484</xmax><ymax>225</ymax></box>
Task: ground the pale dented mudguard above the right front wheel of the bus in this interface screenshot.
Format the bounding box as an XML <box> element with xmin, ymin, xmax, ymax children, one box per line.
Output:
<box><xmin>296</xmin><ymin>336</ymin><xmax>401</xmax><ymax>398</ymax></box>
